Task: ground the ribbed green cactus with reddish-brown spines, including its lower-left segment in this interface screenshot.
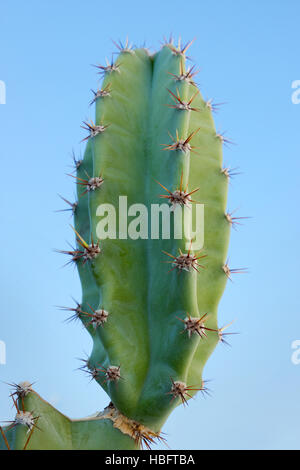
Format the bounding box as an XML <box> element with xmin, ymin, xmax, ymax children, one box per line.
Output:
<box><xmin>0</xmin><ymin>40</ymin><xmax>239</xmax><ymax>449</ymax></box>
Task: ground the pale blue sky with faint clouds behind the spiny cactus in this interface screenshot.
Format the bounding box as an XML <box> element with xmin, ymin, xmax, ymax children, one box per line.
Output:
<box><xmin>0</xmin><ymin>0</ymin><xmax>300</xmax><ymax>449</ymax></box>
